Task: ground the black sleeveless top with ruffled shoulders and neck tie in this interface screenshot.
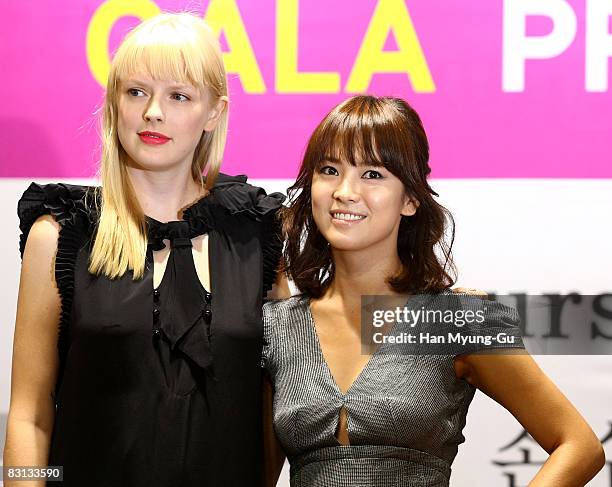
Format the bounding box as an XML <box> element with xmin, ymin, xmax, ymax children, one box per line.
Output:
<box><xmin>18</xmin><ymin>175</ymin><xmax>284</xmax><ymax>487</ymax></box>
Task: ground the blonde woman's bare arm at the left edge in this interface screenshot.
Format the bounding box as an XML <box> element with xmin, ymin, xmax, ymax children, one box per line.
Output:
<box><xmin>4</xmin><ymin>215</ymin><xmax>61</xmax><ymax>487</ymax></box>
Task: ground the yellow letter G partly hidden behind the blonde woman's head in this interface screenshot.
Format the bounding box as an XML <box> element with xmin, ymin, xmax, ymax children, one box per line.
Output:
<box><xmin>86</xmin><ymin>0</ymin><xmax>160</xmax><ymax>86</ymax></box>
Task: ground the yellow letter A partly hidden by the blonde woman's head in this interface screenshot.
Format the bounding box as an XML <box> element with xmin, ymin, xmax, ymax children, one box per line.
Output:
<box><xmin>204</xmin><ymin>0</ymin><xmax>266</xmax><ymax>93</ymax></box>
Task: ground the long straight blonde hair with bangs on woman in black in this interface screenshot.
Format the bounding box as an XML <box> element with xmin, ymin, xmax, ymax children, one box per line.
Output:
<box><xmin>89</xmin><ymin>13</ymin><xmax>228</xmax><ymax>280</ymax></box>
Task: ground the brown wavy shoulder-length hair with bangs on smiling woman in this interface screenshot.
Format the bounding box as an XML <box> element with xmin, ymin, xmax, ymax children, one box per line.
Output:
<box><xmin>282</xmin><ymin>95</ymin><xmax>456</xmax><ymax>298</ymax></box>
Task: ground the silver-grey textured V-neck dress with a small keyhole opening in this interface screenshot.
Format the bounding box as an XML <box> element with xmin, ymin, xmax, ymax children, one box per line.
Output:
<box><xmin>262</xmin><ymin>296</ymin><xmax>523</xmax><ymax>487</ymax></box>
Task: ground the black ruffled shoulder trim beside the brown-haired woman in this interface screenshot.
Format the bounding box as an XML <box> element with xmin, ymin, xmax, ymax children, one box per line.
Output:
<box><xmin>184</xmin><ymin>173</ymin><xmax>285</xmax><ymax>295</ymax></box>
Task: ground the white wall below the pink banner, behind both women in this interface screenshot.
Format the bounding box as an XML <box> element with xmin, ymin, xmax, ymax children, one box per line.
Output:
<box><xmin>0</xmin><ymin>179</ymin><xmax>612</xmax><ymax>487</ymax></box>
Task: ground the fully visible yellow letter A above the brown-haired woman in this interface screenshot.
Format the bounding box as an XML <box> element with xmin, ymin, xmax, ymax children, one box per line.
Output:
<box><xmin>345</xmin><ymin>0</ymin><xmax>436</xmax><ymax>93</ymax></box>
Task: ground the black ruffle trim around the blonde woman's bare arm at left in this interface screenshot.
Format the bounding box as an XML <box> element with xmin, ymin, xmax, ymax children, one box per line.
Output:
<box><xmin>17</xmin><ymin>183</ymin><xmax>95</xmax><ymax>396</ymax></box>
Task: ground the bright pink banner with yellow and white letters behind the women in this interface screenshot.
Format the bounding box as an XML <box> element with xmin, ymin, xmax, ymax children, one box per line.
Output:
<box><xmin>0</xmin><ymin>0</ymin><xmax>612</xmax><ymax>178</ymax></box>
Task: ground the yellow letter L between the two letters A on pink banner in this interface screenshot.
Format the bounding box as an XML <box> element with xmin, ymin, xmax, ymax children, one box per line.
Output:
<box><xmin>276</xmin><ymin>0</ymin><xmax>340</xmax><ymax>93</ymax></box>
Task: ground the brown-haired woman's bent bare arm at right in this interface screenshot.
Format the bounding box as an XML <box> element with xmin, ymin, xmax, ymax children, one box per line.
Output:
<box><xmin>455</xmin><ymin>351</ymin><xmax>605</xmax><ymax>487</ymax></box>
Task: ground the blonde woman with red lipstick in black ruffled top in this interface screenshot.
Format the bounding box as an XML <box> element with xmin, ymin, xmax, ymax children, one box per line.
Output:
<box><xmin>4</xmin><ymin>14</ymin><xmax>283</xmax><ymax>487</ymax></box>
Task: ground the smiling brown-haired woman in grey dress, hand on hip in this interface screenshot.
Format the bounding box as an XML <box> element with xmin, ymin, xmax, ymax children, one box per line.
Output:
<box><xmin>263</xmin><ymin>96</ymin><xmax>604</xmax><ymax>487</ymax></box>
